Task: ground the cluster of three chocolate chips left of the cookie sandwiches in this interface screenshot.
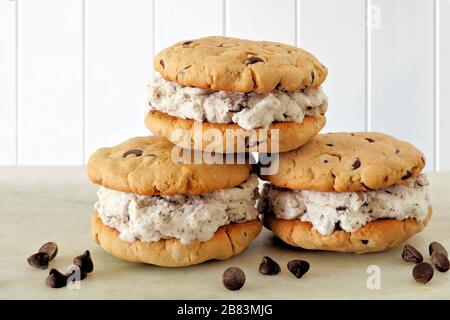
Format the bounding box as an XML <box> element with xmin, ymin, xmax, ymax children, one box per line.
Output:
<box><xmin>27</xmin><ymin>242</ymin><xmax>94</xmax><ymax>288</ymax></box>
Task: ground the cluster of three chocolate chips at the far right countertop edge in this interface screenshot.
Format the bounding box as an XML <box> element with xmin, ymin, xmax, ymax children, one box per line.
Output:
<box><xmin>402</xmin><ymin>241</ymin><xmax>450</xmax><ymax>284</ymax></box>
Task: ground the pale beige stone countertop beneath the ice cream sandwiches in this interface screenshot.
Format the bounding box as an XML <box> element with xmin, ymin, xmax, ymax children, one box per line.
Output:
<box><xmin>0</xmin><ymin>167</ymin><xmax>450</xmax><ymax>299</ymax></box>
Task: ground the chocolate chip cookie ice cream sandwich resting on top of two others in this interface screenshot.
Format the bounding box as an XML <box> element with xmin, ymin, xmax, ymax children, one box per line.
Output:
<box><xmin>146</xmin><ymin>36</ymin><xmax>328</xmax><ymax>153</ymax></box>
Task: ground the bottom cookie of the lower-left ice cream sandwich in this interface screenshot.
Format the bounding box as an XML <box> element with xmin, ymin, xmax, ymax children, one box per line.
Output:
<box><xmin>91</xmin><ymin>211</ymin><xmax>262</xmax><ymax>267</ymax></box>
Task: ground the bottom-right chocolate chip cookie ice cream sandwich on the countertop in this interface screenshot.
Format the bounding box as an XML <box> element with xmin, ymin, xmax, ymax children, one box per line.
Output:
<box><xmin>258</xmin><ymin>132</ymin><xmax>431</xmax><ymax>253</ymax></box>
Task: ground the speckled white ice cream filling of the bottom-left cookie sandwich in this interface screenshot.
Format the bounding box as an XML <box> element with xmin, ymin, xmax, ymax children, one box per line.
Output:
<box><xmin>95</xmin><ymin>174</ymin><xmax>259</xmax><ymax>244</ymax></box>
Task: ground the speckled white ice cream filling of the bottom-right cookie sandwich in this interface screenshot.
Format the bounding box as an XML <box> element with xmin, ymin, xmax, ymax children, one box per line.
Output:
<box><xmin>258</xmin><ymin>175</ymin><xmax>430</xmax><ymax>236</ymax></box>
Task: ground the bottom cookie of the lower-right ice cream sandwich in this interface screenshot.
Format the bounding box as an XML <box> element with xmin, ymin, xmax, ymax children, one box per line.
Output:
<box><xmin>264</xmin><ymin>207</ymin><xmax>432</xmax><ymax>253</ymax></box>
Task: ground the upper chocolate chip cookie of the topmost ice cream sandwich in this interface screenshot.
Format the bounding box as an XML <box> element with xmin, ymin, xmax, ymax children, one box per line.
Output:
<box><xmin>154</xmin><ymin>36</ymin><xmax>328</xmax><ymax>93</ymax></box>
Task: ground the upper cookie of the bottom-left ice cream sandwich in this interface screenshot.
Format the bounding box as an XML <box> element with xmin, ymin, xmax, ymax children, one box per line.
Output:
<box><xmin>88</xmin><ymin>136</ymin><xmax>250</xmax><ymax>195</ymax></box>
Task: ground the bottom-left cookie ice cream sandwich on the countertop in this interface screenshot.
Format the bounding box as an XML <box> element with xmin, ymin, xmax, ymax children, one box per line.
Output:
<box><xmin>88</xmin><ymin>136</ymin><xmax>262</xmax><ymax>267</ymax></box>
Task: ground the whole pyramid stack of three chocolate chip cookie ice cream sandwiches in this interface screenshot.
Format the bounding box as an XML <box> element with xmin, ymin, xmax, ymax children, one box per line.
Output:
<box><xmin>88</xmin><ymin>37</ymin><xmax>431</xmax><ymax>267</ymax></box>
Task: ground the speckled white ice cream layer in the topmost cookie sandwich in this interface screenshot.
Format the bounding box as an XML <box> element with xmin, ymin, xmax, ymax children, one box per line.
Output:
<box><xmin>148</xmin><ymin>77</ymin><xmax>328</xmax><ymax>130</ymax></box>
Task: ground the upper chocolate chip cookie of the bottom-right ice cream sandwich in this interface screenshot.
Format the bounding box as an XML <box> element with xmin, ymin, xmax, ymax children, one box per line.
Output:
<box><xmin>263</xmin><ymin>132</ymin><xmax>425</xmax><ymax>192</ymax></box>
